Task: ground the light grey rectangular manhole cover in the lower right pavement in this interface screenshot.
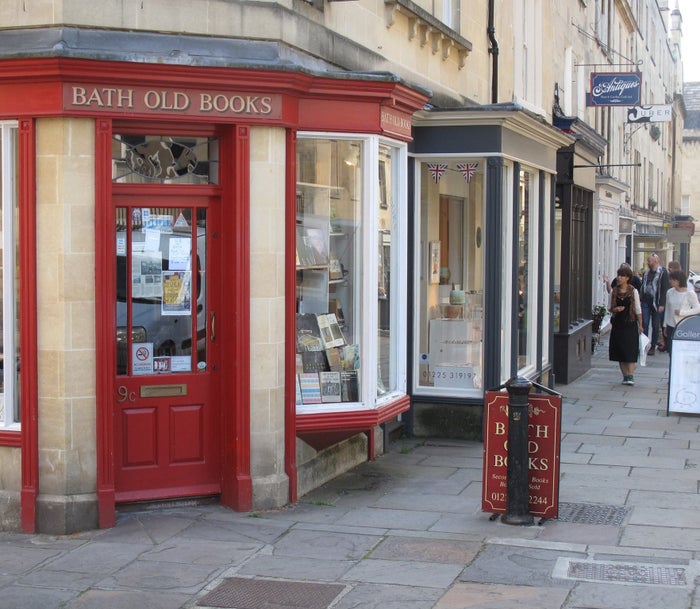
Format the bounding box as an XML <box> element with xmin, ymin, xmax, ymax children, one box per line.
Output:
<box><xmin>567</xmin><ymin>561</ymin><xmax>687</xmax><ymax>586</ymax></box>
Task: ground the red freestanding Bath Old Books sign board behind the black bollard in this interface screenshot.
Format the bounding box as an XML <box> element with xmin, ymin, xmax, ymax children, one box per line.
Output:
<box><xmin>481</xmin><ymin>391</ymin><xmax>561</xmax><ymax>518</ymax></box>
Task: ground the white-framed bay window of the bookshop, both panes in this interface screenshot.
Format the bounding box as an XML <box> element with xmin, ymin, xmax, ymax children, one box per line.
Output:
<box><xmin>295</xmin><ymin>134</ymin><xmax>406</xmax><ymax>413</ymax></box>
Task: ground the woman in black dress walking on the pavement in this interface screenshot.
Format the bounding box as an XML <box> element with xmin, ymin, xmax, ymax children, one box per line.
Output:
<box><xmin>610</xmin><ymin>266</ymin><xmax>642</xmax><ymax>385</ymax></box>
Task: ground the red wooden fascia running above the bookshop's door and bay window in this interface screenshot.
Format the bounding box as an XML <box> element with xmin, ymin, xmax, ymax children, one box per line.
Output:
<box><xmin>0</xmin><ymin>57</ymin><xmax>428</xmax><ymax>140</ymax></box>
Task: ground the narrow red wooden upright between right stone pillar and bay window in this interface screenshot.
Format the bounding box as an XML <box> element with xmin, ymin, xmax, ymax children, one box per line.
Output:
<box><xmin>284</xmin><ymin>130</ymin><xmax>299</xmax><ymax>503</ymax></box>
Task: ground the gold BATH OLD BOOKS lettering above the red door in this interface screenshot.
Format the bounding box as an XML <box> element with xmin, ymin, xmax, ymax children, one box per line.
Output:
<box><xmin>71</xmin><ymin>86</ymin><xmax>273</xmax><ymax>116</ymax></box>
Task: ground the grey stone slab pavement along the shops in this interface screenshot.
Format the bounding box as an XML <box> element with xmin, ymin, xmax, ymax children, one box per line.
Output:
<box><xmin>0</xmin><ymin>344</ymin><xmax>700</xmax><ymax>609</ymax></box>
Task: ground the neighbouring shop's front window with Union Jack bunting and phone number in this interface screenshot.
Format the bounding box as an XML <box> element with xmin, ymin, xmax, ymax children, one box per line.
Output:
<box><xmin>414</xmin><ymin>159</ymin><xmax>484</xmax><ymax>396</ymax></box>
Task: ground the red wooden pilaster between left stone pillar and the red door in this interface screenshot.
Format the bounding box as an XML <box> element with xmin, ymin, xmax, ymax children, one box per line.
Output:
<box><xmin>95</xmin><ymin>118</ymin><xmax>117</xmax><ymax>528</ymax></box>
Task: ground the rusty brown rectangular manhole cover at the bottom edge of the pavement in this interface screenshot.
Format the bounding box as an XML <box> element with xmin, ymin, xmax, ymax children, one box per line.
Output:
<box><xmin>197</xmin><ymin>577</ymin><xmax>345</xmax><ymax>609</ymax></box>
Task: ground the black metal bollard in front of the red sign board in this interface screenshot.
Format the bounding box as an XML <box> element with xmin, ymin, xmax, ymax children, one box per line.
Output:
<box><xmin>501</xmin><ymin>377</ymin><xmax>533</xmax><ymax>525</ymax></box>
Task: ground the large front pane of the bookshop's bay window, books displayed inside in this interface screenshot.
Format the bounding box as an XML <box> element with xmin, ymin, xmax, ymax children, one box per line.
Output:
<box><xmin>296</xmin><ymin>138</ymin><xmax>363</xmax><ymax>404</ymax></box>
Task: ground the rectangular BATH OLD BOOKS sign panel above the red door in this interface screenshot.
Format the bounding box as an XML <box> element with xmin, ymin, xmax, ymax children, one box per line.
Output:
<box><xmin>63</xmin><ymin>83</ymin><xmax>282</xmax><ymax>120</ymax></box>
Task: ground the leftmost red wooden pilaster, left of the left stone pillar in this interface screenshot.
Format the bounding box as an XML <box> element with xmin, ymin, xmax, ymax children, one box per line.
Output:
<box><xmin>18</xmin><ymin>119</ymin><xmax>39</xmax><ymax>533</ymax></box>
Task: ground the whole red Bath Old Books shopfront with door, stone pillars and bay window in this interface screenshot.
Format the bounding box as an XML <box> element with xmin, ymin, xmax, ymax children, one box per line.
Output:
<box><xmin>0</xmin><ymin>59</ymin><xmax>426</xmax><ymax>532</ymax></box>
